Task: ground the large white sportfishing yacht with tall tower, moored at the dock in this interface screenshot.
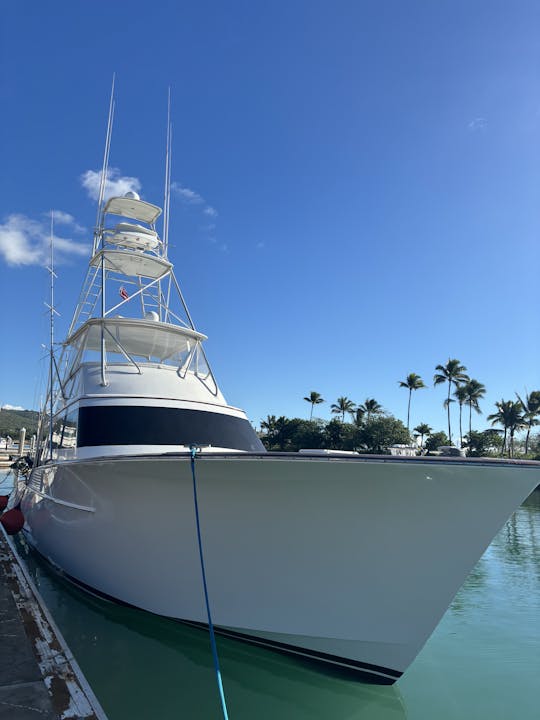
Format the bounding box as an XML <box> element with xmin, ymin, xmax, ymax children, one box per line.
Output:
<box><xmin>16</xmin><ymin>187</ymin><xmax>540</xmax><ymax>684</ymax></box>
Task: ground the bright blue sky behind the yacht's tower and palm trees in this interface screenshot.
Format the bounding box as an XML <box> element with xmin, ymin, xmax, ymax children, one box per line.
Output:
<box><xmin>0</xmin><ymin>0</ymin><xmax>540</xmax><ymax>436</ymax></box>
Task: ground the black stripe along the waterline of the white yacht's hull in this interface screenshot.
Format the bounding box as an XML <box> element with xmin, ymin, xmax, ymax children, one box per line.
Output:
<box><xmin>23</xmin><ymin>541</ymin><xmax>403</xmax><ymax>685</ymax></box>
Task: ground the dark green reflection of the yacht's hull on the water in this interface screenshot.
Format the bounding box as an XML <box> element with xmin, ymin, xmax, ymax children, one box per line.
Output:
<box><xmin>19</xmin><ymin>543</ymin><xmax>407</xmax><ymax>720</ymax></box>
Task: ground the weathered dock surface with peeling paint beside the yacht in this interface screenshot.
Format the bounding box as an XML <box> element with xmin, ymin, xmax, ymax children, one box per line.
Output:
<box><xmin>0</xmin><ymin>526</ymin><xmax>107</xmax><ymax>720</ymax></box>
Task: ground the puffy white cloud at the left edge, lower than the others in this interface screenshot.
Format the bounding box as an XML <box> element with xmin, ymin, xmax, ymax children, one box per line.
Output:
<box><xmin>0</xmin><ymin>215</ymin><xmax>89</xmax><ymax>266</ymax></box>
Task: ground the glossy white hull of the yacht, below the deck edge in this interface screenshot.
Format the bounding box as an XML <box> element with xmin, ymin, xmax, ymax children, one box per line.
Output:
<box><xmin>22</xmin><ymin>453</ymin><xmax>540</xmax><ymax>683</ymax></box>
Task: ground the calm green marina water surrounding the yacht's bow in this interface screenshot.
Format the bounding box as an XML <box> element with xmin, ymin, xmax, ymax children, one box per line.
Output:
<box><xmin>0</xmin><ymin>470</ymin><xmax>540</xmax><ymax>720</ymax></box>
